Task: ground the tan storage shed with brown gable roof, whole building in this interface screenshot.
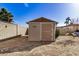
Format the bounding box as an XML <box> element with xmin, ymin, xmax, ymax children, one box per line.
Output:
<box><xmin>27</xmin><ymin>17</ymin><xmax>57</xmax><ymax>41</ymax></box>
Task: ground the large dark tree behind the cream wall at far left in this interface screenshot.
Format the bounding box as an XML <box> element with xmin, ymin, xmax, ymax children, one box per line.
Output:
<box><xmin>0</xmin><ymin>8</ymin><xmax>13</xmax><ymax>23</ymax></box>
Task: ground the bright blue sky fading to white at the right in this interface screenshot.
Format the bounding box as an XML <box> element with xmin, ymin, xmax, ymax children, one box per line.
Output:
<box><xmin>0</xmin><ymin>3</ymin><xmax>79</xmax><ymax>26</ymax></box>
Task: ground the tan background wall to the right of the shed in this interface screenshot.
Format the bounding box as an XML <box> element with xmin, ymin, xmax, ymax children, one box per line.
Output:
<box><xmin>57</xmin><ymin>25</ymin><xmax>79</xmax><ymax>35</ymax></box>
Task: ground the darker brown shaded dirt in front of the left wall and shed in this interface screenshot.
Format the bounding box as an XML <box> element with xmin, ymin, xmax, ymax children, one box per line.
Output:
<box><xmin>0</xmin><ymin>36</ymin><xmax>51</xmax><ymax>54</ymax></box>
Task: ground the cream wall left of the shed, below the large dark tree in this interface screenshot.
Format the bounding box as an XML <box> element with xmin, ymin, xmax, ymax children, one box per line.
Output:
<box><xmin>0</xmin><ymin>21</ymin><xmax>26</xmax><ymax>40</ymax></box>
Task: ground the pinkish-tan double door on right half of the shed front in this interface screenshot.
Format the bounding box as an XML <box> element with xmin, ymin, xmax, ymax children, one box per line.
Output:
<box><xmin>41</xmin><ymin>24</ymin><xmax>53</xmax><ymax>41</ymax></box>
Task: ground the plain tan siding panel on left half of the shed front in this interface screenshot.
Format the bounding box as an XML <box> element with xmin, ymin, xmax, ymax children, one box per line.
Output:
<box><xmin>29</xmin><ymin>22</ymin><xmax>40</xmax><ymax>41</ymax></box>
